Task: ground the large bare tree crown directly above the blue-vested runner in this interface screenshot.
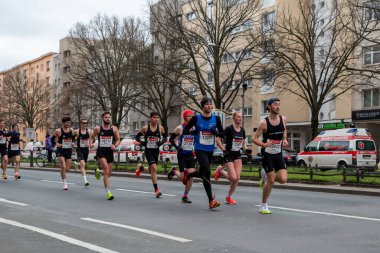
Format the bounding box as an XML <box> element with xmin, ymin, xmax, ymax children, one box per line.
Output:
<box><xmin>150</xmin><ymin>0</ymin><xmax>261</xmax><ymax>110</ymax></box>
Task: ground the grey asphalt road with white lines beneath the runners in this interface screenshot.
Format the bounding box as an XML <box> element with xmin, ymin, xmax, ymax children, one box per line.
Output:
<box><xmin>0</xmin><ymin>168</ymin><xmax>380</xmax><ymax>253</ymax></box>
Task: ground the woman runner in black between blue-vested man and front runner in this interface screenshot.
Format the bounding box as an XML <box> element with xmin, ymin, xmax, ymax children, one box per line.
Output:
<box><xmin>214</xmin><ymin>112</ymin><xmax>252</xmax><ymax>205</ymax></box>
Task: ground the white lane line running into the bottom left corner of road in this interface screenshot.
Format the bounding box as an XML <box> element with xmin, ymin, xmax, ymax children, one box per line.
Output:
<box><xmin>0</xmin><ymin>218</ymin><xmax>118</xmax><ymax>253</ymax></box>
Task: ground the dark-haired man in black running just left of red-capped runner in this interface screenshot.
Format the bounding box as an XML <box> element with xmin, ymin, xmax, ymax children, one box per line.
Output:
<box><xmin>135</xmin><ymin>112</ymin><xmax>167</xmax><ymax>198</ymax></box>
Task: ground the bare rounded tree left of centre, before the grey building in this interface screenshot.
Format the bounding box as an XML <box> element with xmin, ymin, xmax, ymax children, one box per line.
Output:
<box><xmin>65</xmin><ymin>15</ymin><xmax>146</xmax><ymax>126</ymax></box>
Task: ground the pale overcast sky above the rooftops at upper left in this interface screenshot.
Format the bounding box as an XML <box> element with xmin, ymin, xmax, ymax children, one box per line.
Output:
<box><xmin>0</xmin><ymin>0</ymin><xmax>147</xmax><ymax>71</ymax></box>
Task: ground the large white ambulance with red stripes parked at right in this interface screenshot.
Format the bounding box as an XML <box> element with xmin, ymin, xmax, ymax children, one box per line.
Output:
<box><xmin>297</xmin><ymin>128</ymin><xmax>377</xmax><ymax>170</ymax></box>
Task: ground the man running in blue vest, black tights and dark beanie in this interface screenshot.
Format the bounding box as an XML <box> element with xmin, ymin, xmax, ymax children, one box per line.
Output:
<box><xmin>182</xmin><ymin>97</ymin><xmax>224</xmax><ymax>209</ymax></box>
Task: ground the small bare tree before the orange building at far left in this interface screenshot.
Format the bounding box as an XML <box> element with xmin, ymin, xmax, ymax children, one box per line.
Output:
<box><xmin>3</xmin><ymin>68</ymin><xmax>54</xmax><ymax>128</ymax></box>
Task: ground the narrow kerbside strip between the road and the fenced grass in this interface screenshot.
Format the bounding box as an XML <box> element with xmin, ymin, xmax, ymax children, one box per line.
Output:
<box><xmin>17</xmin><ymin>163</ymin><xmax>380</xmax><ymax>197</ymax></box>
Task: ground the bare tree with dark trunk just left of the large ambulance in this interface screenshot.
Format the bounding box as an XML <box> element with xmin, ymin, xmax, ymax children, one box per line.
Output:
<box><xmin>262</xmin><ymin>0</ymin><xmax>379</xmax><ymax>137</ymax></box>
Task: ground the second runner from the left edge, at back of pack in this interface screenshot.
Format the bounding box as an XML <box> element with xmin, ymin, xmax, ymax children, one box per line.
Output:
<box><xmin>8</xmin><ymin>125</ymin><xmax>24</xmax><ymax>179</ymax></box>
